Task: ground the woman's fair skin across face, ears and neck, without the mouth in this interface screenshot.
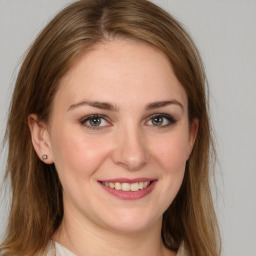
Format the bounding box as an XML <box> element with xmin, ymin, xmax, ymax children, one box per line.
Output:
<box><xmin>29</xmin><ymin>40</ymin><xmax>198</xmax><ymax>256</ymax></box>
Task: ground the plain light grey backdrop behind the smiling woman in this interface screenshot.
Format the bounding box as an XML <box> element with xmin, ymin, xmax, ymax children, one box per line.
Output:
<box><xmin>0</xmin><ymin>0</ymin><xmax>256</xmax><ymax>256</ymax></box>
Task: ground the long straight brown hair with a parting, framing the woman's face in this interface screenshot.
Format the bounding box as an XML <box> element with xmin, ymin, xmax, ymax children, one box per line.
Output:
<box><xmin>0</xmin><ymin>0</ymin><xmax>220</xmax><ymax>256</ymax></box>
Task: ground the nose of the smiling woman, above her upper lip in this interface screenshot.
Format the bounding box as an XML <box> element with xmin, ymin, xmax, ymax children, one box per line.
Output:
<box><xmin>112</xmin><ymin>125</ymin><xmax>149</xmax><ymax>171</ymax></box>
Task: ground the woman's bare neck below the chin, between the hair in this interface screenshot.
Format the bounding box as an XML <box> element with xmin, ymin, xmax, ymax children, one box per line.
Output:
<box><xmin>53</xmin><ymin>206</ymin><xmax>176</xmax><ymax>256</ymax></box>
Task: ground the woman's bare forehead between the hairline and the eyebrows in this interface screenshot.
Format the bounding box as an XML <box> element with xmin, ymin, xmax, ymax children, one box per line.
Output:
<box><xmin>55</xmin><ymin>40</ymin><xmax>187</xmax><ymax>111</ymax></box>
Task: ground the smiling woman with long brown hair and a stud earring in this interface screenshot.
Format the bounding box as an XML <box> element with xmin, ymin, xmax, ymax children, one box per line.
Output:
<box><xmin>0</xmin><ymin>0</ymin><xmax>219</xmax><ymax>256</ymax></box>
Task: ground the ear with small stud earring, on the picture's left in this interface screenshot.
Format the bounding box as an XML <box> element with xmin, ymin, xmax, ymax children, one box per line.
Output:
<box><xmin>28</xmin><ymin>114</ymin><xmax>53</xmax><ymax>164</ymax></box>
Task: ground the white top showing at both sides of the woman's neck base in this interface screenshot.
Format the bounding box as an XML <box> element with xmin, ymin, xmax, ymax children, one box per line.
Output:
<box><xmin>46</xmin><ymin>242</ymin><xmax>188</xmax><ymax>256</ymax></box>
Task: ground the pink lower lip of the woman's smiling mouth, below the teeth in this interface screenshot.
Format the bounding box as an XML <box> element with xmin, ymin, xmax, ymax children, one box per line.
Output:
<box><xmin>99</xmin><ymin>181</ymin><xmax>157</xmax><ymax>200</ymax></box>
